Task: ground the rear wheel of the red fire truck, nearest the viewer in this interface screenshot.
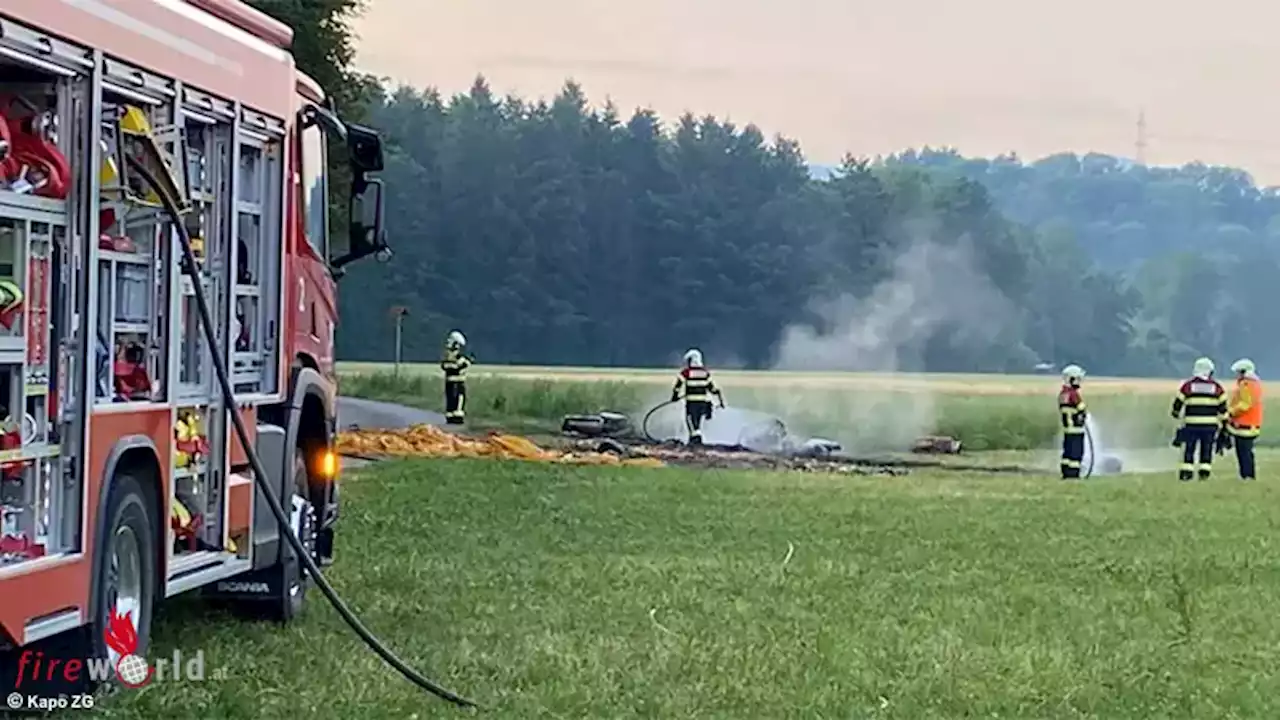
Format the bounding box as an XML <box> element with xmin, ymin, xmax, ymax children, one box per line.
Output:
<box><xmin>92</xmin><ymin>473</ymin><xmax>159</xmax><ymax>664</ymax></box>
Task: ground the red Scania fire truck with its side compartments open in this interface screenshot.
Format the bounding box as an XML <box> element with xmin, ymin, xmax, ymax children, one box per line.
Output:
<box><xmin>0</xmin><ymin>0</ymin><xmax>389</xmax><ymax>683</ymax></box>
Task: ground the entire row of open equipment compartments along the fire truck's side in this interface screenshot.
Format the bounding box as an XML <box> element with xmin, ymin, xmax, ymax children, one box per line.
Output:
<box><xmin>0</xmin><ymin>18</ymin><xmax>285</xmax><ymax>576</ymax></box>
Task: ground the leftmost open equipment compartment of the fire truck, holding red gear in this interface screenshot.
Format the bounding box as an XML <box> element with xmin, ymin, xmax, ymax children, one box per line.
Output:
<box><xmin>0</xmin><ymin>25</ymin><xmax>93</xmax><ymax>571</ymax></box>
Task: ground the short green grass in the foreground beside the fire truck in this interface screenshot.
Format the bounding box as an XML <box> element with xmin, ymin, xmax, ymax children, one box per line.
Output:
<box><xmin>94</xmin><ymin>460</ymin><xmax>1280</xmax><ymax>720</ymax></box>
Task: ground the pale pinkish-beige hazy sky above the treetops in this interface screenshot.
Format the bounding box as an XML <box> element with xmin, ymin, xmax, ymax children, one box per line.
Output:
<box><xmin>356</xmin><ymin>0</ymin><xmax>1280</xmax><ymax>183</ymax></box>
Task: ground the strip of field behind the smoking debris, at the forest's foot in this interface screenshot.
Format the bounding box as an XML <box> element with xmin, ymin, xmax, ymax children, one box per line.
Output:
<box><xmin>340</xmin><ymin>366</ymin><xmax>1228</xmax><ymax>451</ymax></box>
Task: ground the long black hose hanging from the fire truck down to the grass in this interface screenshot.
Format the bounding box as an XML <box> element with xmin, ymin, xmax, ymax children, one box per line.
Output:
<box><xmin>125</xmin><ymin>154</ymin><xmax>476</xmax><ymax>707</ymax></box>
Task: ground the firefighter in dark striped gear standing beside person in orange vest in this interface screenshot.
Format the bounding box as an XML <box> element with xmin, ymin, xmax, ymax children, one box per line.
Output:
<box><xmin>1171</xmin><ymin>357</ymin><xmax>1230</xmax><ymax>482</ymax></box>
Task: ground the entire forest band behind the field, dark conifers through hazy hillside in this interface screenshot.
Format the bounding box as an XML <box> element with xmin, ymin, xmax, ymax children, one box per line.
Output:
<box><xmin>249</xmin><ymin>0</ymin><xmax>1280</xmax><ymax>374</ymax></box>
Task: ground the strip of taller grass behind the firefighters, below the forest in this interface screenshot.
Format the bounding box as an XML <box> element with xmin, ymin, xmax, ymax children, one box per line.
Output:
<box><xmin>340</xmin><ymin>372</ymin><xmax>1228</xmax><ymax>450</ymax></box>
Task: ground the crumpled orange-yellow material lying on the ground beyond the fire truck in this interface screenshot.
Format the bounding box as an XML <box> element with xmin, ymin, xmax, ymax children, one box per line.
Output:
<box><xmin>337</xmin><ymin>425</ymin><xmax>664</xmax><ymax>468</ymax></box>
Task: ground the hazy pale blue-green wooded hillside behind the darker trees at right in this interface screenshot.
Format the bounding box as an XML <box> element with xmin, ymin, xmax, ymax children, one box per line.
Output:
<box><xmin>886</xmin><ymin>150</ymin><xmax>1280</xmax><ymax>373</ymax></box>
